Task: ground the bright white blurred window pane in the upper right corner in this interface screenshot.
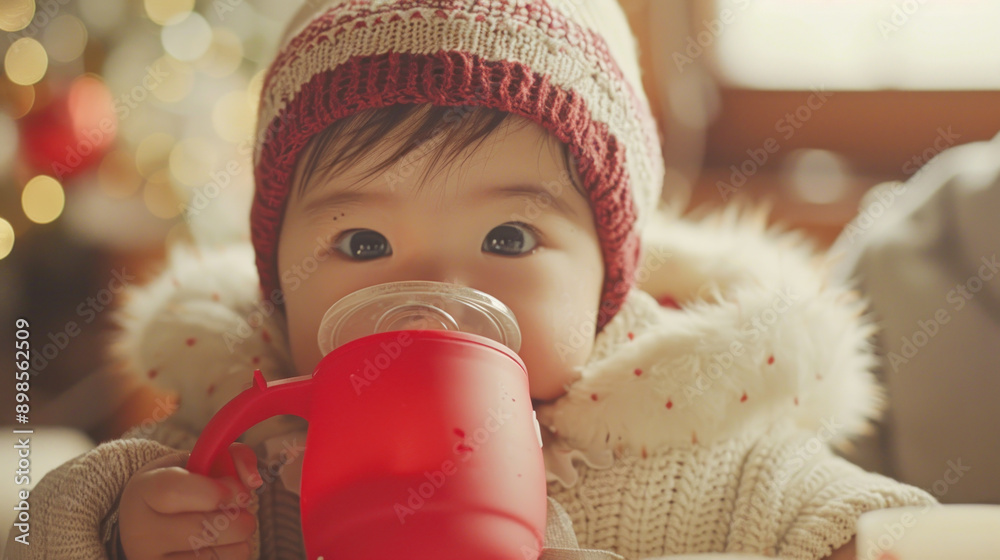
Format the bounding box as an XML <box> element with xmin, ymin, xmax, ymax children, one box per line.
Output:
<box><xmin>720</xmin><ymin>0</ymin><xmax>1000</xmax><ymax>90</ymax></box>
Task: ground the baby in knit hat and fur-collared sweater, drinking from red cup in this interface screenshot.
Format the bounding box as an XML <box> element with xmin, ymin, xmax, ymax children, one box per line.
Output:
<box><xmin>9</xmin><ymin>0</ymin><xmax>933</xmax><ymax>560</ymax></box>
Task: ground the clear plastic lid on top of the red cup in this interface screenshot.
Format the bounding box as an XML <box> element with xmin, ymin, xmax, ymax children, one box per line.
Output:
<box><xmin>318</xmin><ymin>281</ymin><xmax>521</xmax><ymax>356</ymax></box>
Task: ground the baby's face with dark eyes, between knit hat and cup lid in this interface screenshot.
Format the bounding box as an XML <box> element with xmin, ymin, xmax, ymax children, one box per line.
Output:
<box><xmin>278</xmin><ymin>116</ymin><xmax>604</xmax><ymax>400</ymax></box>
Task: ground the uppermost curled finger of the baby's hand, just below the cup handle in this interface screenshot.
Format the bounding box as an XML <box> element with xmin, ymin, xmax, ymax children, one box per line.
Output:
<box><xmin>137</xmin><ymin>467</ymin><xmax>247</xmax><ymax>514</ymax></box>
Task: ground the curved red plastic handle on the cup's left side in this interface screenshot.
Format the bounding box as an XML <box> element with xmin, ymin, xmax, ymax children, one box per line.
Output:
<box><xmin>187</xmin><ymin>369</ymin><xmax>312</xmax><ymax>479</ymax></box>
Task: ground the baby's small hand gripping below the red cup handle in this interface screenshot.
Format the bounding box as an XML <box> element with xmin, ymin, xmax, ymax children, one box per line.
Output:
<box><xmin>118</xmin><ymin>443</ymin><xmax>263</xmax><ymax>560</ymax></box>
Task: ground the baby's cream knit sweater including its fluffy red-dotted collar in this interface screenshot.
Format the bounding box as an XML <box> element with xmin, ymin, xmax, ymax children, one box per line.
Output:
<box><xmin>7</xmin><ymin>212</ymin><xmax>933</xmax><ymax>560</ymax></box>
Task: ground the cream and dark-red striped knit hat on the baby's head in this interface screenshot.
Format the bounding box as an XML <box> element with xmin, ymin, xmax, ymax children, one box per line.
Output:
<box><xmin>250</xmin><ymin>0</ymin><xmax>663</xmax><ymax>331</ymax></box>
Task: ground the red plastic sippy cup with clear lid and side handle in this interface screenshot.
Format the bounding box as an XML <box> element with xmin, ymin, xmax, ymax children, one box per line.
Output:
<box><xmin>188</xmin><ymin>282</ymin><xmax>547</xmax><ymax>560</ymax></box>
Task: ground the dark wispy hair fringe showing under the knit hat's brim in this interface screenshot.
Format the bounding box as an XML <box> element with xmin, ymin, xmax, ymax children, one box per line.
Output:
<box><xmin>291</xmin><ymin>103</ymin><xmax>586</xmax><ymax>198</ymax></box>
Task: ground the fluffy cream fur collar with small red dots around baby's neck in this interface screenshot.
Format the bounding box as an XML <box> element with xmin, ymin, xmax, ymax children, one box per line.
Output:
<box><xmin>116</xmin><ymin>209</ymin><xmax>882</xmax><ymax>462</ymax></box>
